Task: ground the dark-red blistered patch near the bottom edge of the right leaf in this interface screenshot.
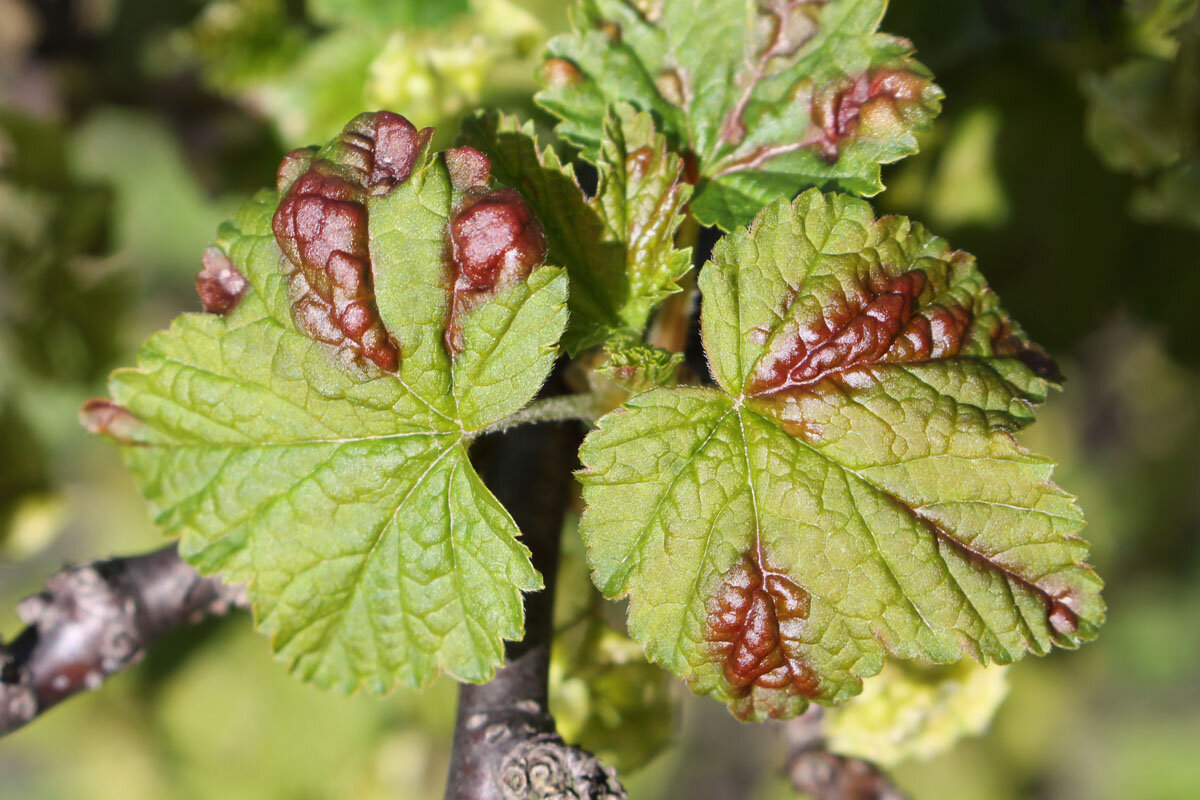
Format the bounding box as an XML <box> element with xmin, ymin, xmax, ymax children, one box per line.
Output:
<box><xmin>706</xmin><ymin>557</ymin><xmax>821</xmax><ymax>698</ymax></box>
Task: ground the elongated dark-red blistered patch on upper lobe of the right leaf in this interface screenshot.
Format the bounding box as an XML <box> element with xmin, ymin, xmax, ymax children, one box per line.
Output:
<box><xmin>746</xmin><ymin>270</ymin><xmax>972</xmax><ymax>397</ymax></box>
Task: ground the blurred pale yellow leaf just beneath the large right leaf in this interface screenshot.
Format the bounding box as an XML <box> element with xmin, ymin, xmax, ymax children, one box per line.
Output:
<box><xmin>824</xmin><ymin>661</ymin><xmax>1008</xmax><ymax>769</ymax></box>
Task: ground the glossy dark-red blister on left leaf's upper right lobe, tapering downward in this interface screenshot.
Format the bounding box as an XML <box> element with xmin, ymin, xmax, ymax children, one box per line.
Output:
<box><xmin>444</xmin><ymin>188</ymin><xmax>546</xmax><ymax>356</ymax></box>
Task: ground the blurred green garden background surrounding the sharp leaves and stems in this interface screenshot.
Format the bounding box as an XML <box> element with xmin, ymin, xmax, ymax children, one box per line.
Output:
<box><xmin>0</xmin><ymin>0</ymin><xmax>1200</xmax><ymax>800</ymax></box>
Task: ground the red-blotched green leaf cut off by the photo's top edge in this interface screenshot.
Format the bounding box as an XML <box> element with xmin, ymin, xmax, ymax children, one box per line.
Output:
<box><xmin>536</xmin><ymin>0</ymin><xmax>942</xmax><ymax>230</ymax></box>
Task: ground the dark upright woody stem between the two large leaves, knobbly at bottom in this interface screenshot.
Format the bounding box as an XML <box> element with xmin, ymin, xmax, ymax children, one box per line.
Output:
<box><xmin>445</xmin><ymin>410</ymin><xmax>625</xmax><ymax>800</ymax></box>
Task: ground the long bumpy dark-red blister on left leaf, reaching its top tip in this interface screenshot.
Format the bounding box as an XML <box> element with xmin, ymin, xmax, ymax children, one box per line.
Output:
<box><xmin>272</xmin><ymin>112</ymin><xmax>433</xmax><ymax>372</ymax></box>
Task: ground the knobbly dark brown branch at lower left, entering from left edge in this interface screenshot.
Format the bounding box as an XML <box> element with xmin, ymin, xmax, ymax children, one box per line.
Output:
<box><xmin>0</xmin><ymin>545</ymin><xmax>246</xmax><ymax>735</ymax></box>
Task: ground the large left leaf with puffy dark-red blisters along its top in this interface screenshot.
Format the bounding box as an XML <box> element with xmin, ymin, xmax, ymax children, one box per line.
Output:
<box><xmin>84</xmin><ymin>112</ymin><xmax>566</xmax><ymax>692</ymax></box>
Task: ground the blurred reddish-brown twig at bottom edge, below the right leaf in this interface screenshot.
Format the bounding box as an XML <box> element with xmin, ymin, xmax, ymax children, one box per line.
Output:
<box><xmin>784</xmin><ymin>705</ymin><xmax>906</xmax><ymax>800</ymax></box>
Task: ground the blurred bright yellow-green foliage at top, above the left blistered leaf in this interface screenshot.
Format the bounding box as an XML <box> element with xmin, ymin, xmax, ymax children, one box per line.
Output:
<box><xmin>171</xmin><ymin>0</ymin><xmax>560</xmax><ymax>148</ymax></box>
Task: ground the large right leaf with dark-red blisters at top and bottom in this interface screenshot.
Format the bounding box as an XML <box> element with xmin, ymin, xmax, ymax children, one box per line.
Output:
<box><xmin>581</xmin><ymin>190</ymin><xmax>1104</xmax><ymax>720</ymax></box>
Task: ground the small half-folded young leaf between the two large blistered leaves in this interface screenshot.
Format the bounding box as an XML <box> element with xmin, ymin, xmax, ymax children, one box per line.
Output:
<box><xmin>462</xmin><ymin>107</ymin><xmax>691</xmax><ymax>355</ymax></box>
